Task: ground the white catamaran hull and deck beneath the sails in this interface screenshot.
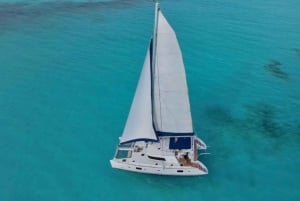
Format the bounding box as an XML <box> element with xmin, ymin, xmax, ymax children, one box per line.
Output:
<box><xmin>110</xmin><ymin>136</ymin><xmax>208</xmax><ymax>176</ymax></box>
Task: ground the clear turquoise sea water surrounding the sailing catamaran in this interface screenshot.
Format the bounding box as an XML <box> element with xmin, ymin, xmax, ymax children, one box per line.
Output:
<box><xmin>0</xmin><ymin>0</ymin><xmax>300</xmax><ymax>201</ymax></box>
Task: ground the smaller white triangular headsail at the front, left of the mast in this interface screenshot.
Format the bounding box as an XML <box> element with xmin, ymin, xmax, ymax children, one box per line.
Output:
<box><xmin>120</xmin><ymin>48</ymin><xmax>157</xmax><ymax>143</ymax></box>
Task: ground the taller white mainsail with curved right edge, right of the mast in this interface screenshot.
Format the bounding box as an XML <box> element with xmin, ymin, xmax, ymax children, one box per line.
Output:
<box><xmin>153</xmin><ymin>10</ymin><xmax>193</xmax><ymax>134</ymax></box>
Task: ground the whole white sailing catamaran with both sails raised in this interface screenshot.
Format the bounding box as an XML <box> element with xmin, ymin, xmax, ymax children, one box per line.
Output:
<box><xmin>110</xmin><ymin>2</ymin><xmax>208</xmax><ymax>176</ymax></box>
